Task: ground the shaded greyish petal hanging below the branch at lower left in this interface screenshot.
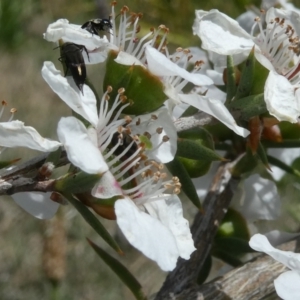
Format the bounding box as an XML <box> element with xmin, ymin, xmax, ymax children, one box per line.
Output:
<box><xmin>11</xmin><ymin>192</ymin><xmax>59</xmax><ymax>219</ymax></box>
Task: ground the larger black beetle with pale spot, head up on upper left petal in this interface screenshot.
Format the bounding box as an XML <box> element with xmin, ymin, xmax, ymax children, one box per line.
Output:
<box><xmin>59</xmin><ymin>43</ymin><xmax>89</xmax><ymax>94</ymax></box>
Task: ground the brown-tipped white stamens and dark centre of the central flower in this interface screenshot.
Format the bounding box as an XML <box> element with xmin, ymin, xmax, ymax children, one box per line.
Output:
<box><xmin>97</xmin><ymin>88</ymin><xmax>181</xmax><ymax>204</ymax></box>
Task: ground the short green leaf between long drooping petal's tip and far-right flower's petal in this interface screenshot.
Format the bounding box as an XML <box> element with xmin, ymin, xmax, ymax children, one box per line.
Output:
<box><xmin>229</xmin><ymin>94</ymin><xmax>268</xmax><ymax>121</ymax></box>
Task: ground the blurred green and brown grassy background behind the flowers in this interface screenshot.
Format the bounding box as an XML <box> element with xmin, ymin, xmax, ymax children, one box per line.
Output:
<box><xmin>0</xmin><ymin>0</ymin><xmax>300</xmax><ymax>300</ymax></box>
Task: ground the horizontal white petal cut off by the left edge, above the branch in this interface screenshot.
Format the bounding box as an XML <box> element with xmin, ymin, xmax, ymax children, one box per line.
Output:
<box><xmin>0</xmin><ymin>121</ymin><xmax>61</xmax><ymax>152</ymax></box>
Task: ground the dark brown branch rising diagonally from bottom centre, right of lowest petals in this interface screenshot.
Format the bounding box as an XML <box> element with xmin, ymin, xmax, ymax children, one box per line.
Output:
<box><xmin>155</xmin><ymin>163</ymin><xmax>240</xmax><ymax>300</ymax></box>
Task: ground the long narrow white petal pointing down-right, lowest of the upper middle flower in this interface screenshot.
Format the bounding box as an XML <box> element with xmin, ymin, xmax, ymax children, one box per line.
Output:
<box><xmin>178</xmin><ymin>94</ymin><xmax>250</xmax><ymax>137</ymax></box>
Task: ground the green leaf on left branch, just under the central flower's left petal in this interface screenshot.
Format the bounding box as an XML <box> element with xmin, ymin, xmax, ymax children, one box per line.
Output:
<box><xmin>54</xmin><ymin>172</ymin><xmax>101</xmax><ymax>194</ymax></box>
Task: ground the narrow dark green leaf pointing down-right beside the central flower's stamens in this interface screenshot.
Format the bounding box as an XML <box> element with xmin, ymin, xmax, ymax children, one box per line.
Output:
<box><xmin>166</xmin><ymin>157</ymin><xmax>201</xmax><ymax>209</ymax></box>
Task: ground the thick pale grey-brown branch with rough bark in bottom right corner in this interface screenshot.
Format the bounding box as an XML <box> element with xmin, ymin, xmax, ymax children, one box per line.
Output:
<box><xmin>166</xmin><ymin>238</ymin><xmax>300</xmax><ymax>300</ymax></box>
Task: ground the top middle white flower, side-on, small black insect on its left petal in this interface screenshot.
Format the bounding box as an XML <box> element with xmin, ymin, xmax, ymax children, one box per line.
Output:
<box><xmin>44</xmin><ymin>5</ymin><xmax>249</xmax><ymax>136</ymax></box>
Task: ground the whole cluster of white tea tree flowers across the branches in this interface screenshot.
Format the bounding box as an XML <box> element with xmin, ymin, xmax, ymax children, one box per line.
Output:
<box><xmin>0</xmin><ymin>1</ymin><xmax>300</xmax><ymax>290</ymax></box>
